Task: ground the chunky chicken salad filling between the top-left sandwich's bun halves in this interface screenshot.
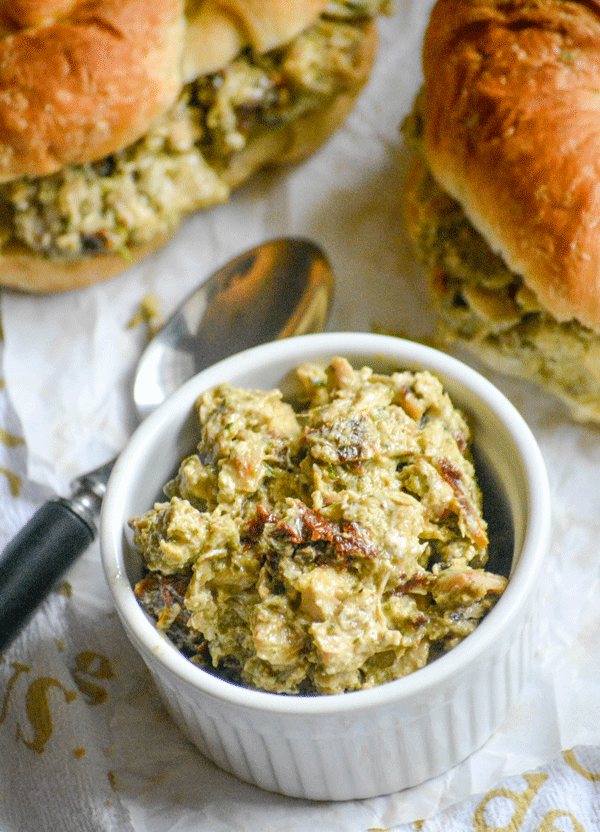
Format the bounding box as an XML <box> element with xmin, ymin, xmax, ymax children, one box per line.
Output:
<box><xmin>0</xmin><ymin>0</ymin><xmax>388</xmax><ymax>260</ymax></box>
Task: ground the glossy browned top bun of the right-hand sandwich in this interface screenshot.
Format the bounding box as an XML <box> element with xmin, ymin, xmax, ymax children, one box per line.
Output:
<box><xmin>423</xmin><ymin>0</ymin><xmax>600</xmax><ymax>330</ymax></box>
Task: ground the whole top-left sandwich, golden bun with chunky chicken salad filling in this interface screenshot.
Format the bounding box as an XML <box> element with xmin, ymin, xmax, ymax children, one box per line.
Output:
<box><xmin>0</xmin><ymin>0</ymin><xmax>388</xmax><ymax>292</ymax></box>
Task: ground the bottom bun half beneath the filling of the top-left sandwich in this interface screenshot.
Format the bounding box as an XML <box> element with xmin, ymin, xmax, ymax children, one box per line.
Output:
<box><xmin>0</xmin><ymin>22</ymin><xmax>378</xmax><ymax>294</ymax></box>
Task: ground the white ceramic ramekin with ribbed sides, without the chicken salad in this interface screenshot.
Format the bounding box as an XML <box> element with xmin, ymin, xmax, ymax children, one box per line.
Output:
<box><xmin>101</xmin><ymin>333</ymin><xmax>550</xmax><ymax>800</ymax></box>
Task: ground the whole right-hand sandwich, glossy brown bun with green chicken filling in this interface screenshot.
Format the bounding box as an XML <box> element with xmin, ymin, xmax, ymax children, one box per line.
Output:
<box><xmin>403</xmin><ymin>0</ymin><xmax>600</xmax><ymax>422</ymax></box>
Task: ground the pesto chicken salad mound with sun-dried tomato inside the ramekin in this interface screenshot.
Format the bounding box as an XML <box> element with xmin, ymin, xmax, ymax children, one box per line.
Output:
<box><xmin>130</xmin><ymin>357</ymin><xmax>507</xmax><ymax>694</ymax></box>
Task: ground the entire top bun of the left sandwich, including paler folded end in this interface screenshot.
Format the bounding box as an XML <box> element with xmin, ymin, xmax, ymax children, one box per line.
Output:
<box><xmin>0</xmin><ymin>0</ymin><xmax>326</xmax><ymax>181</ymax></box>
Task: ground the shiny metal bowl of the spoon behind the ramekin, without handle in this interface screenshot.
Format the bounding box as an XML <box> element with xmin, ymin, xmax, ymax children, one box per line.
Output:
<box><xmin>133</xmin><ymin>237</ymin><xmax>333</xmax><ymax>419</ymax></box>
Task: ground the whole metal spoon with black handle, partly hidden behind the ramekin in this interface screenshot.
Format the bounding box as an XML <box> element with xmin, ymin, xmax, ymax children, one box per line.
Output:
<box><xmin>0</xmin><ymin>238</ymin><xmax>334</xmax><ymax>651</ymax></box>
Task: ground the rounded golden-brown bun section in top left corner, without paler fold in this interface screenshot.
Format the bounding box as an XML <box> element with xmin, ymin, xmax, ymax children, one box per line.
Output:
<box><xmin>0</xmin><ymin>0</ymin><xmax>185</xmax><ymax>181</ymax></box>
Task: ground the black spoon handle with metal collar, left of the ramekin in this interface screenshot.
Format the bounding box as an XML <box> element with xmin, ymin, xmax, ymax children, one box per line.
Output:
<box><xmin>0</xmin><ymin>462</ymin><xmax>114</xmax><ymax>653</ymax></box>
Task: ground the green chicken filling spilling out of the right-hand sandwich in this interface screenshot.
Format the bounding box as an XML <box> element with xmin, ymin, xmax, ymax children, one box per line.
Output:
<box><xmin>403</xmin><ymin>99</ymin><xmax>600</xmax><ymax>420</ymax></box>
